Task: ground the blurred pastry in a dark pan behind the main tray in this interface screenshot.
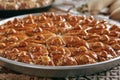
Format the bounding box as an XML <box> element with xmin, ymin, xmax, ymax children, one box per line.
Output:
<box><xmin>0</xmin><ymin>0</ymin><xmax>54</xmax><ymax>18</ymax></box>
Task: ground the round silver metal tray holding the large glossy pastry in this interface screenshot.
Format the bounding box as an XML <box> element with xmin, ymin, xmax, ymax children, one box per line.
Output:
<box><xmin>0</xmin><ymin>14</ymin><xmax>120</xmax><ymax>78</ymax></box>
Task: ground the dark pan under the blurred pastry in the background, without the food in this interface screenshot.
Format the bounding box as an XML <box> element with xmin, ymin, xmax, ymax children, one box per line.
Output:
<box><xmin>0</xmin><ymin>0</ymin><xmax>55</xmax><ymax>18</ymax></box>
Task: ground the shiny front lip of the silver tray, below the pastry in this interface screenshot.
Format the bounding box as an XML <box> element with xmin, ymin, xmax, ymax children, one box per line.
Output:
<box><xmin>0</xmin><ymin>56</ymin><xmax>120</xmax><ymax>70</ymax></box>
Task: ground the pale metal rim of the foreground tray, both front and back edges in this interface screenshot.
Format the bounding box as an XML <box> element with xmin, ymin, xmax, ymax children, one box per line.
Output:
<box><xmin>0</xmin><ymin>13</ymin><xmax>120</xmax><ymax>77</ymax></box>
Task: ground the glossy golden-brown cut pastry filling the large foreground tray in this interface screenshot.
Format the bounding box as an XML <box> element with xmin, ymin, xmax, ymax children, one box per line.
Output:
<box><xmin>0</xmin><ymin>13</ymin><xmax>120</xmax><ymax>66</ymax></box>
